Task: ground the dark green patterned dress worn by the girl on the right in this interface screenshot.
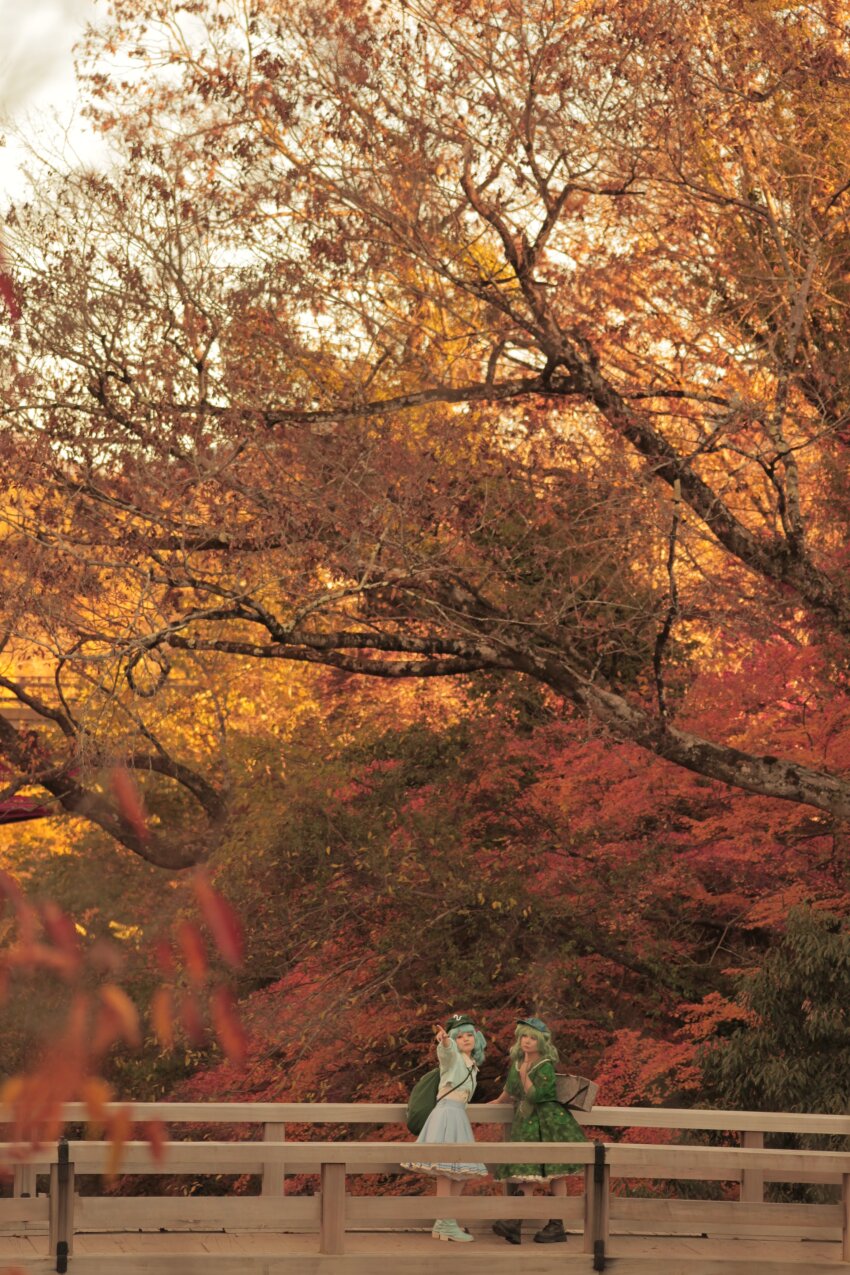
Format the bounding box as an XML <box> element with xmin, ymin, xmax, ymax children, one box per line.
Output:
<box><xmin>493</xmin><ymin>1060</ymin><xmax>587</xmax><ymax>1182</ymax></box>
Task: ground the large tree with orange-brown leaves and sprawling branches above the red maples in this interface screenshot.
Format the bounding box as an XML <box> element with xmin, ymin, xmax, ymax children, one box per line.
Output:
<box><xmin>0</xmin><ymin>0</ymin><xmax>850</xmax><ymax>867</ymax></box>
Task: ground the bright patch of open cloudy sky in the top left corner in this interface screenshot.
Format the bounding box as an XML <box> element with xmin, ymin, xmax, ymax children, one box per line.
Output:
<box><xmin>0</xmin><ymin>0</ymin><xmax>98</xmax><ymax>204</ymax></box>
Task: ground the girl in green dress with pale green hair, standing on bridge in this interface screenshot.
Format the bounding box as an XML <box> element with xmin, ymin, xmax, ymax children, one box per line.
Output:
<box><xmin>493</xmin><ymin>1017</ymin><xmax>586</xmax><ymax>1244</ymax></box>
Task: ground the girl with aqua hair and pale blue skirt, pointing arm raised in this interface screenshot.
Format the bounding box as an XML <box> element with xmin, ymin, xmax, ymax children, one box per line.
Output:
<box><xmin>401</xmin><ymin>1014</ymin><xmax>487</xmax><ymax>1243</ymax></box>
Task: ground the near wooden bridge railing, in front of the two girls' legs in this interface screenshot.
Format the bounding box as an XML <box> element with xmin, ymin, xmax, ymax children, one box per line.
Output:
<box><xmin>0</xmin><ymin>1141</ymin><xmax>850</xmax><ymax>1271</ymax></box>
